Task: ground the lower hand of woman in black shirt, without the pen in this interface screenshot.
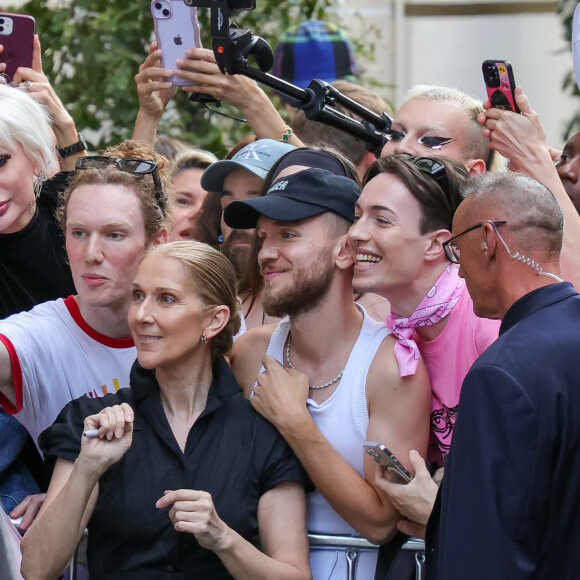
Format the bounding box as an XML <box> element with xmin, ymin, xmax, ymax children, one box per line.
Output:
<box><xmin>155</xmin><ymin>489</ymin><xmax>231</xmax><ymax>552</ymax></box>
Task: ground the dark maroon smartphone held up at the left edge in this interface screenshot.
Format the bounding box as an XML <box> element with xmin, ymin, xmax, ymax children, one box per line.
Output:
<box><xmin>0</xmin><ymin>12</ymin><xmax>34</xmax><ymax>83</ymax></box>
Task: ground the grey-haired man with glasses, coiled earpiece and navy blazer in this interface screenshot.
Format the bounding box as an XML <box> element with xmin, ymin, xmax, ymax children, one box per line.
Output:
<box><xmin>427</xmin><ymin>172</ymin><xmax>580</xmax><ymax>580</ymax></box>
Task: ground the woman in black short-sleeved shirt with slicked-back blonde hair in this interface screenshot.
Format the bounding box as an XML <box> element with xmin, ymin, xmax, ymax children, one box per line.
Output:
<box><xmin>22</xmin><ymin>241</ymin><xmax>311</xmax><ymax>580</ymax></box>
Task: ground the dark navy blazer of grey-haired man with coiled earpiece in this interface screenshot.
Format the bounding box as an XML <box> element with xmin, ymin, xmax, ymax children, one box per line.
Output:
<box><xmin>427</xmin><ymin>283</ymin><xmax>580</xmax><ymax>580</ymax></box>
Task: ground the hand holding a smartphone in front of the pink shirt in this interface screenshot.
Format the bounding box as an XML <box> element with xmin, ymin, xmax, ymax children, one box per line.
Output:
<box><xmin>375</xmin><ymin>449</ymin><xmax>439</xmax><ymax>525</ymax></box>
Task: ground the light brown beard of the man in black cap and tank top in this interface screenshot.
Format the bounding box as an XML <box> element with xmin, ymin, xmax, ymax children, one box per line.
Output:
<box><xmin>262</xmin><ymin>248</ymin><xmax>334</xmax><ymax>318</ymax></box>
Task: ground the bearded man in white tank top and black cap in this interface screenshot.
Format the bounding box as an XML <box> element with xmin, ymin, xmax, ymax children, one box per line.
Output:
<box><xmin>224</xmin><ymin>169</ymin><xmax>430</xmax><ymax>580</ymax></box>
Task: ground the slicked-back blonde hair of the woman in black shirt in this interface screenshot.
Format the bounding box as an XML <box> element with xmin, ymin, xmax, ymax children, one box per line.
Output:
<box><xmin>146</xmin><ymin>240</ymin><xmax>241</xmax><ymax>356</ymax></box>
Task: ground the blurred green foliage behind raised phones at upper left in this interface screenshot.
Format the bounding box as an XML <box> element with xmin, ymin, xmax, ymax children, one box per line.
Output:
<box><xmin>18</xmin><ymin>0</ymin><xmax>348</xmax><ymax>154</ymax></box>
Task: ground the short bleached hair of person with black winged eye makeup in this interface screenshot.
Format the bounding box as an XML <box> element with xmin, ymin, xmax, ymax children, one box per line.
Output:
<box><xmin>405</xmin><ymin>85</ymin><xmax>506</xmax><ymax>171</ymax></box>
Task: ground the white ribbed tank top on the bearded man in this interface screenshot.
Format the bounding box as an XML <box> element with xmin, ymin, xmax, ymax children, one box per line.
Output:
<box><xmin>260</xmin><ymin>305</ymin><xmax>391</xmax><ymax>580</ymax></box>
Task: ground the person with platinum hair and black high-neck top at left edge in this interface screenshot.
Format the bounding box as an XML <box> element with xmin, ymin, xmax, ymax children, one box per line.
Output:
<box><xmin>0</xmin><ymin>83</ymin><xmax>74</xmax><ymax>318</ymax></box>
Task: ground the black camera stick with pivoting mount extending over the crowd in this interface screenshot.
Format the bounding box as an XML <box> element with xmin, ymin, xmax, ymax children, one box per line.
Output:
<box><xmin>184</xmin><ymin>0</ymin><xmax>393</xmax><ymax>157</ymax></box>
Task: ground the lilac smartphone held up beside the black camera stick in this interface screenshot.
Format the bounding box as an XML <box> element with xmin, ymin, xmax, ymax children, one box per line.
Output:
<box><xmin>151</xmin><ymin>0</ymin><xmax>201</xmax><ymax>85</ymax></box>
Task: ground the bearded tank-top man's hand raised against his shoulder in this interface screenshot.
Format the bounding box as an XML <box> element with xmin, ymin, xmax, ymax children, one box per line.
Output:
<box><xmin>250</xmin><ymin>355</ymin><xmax>310</xmax><ymax>431</ymax></box>
